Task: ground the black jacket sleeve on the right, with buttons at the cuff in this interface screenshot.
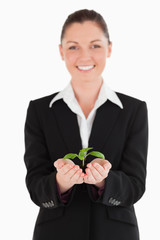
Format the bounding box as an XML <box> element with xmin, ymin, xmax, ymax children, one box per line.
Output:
<box><xmin>87</xmin><ymin>102</ymin><xmax>148</xmax><ymax>207</ymax></box>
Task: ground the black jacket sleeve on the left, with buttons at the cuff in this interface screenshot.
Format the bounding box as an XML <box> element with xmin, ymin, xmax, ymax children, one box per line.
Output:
<box><xmin>24</xmin><ymin>101</ymin><xmax>75</xmax><ymax>208</ymax></box>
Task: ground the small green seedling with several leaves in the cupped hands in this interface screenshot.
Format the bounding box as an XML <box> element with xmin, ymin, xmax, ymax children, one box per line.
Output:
<box><xmin>63</xmin><ymin>147</ymin><xmax>105</xmax><ymax>167</ymax></box>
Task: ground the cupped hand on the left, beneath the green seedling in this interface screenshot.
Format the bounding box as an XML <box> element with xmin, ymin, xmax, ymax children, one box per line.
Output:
<box><xmin>54</xmin><ymin>159</ymin><xmax>84</xmax><ymax>193</ymax></box>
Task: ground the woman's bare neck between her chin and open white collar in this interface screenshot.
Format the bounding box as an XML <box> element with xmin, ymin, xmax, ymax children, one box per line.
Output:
<box><xmin>71</xmin><ymin>78</ymin><xmax>103</xmax><ymax>105</ymax></box>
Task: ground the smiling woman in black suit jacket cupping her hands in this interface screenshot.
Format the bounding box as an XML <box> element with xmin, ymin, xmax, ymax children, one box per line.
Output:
<box><xmin>24</xmin><ymin>9</ymin><xmax>148</xmax><ymax>240</ymax></box>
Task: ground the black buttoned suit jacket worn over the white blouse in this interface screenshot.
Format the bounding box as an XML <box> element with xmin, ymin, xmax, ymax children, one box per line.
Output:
<box><xmin>24</xmin><ymin>93</ymin><xmax>148</xmax><ymax>240</ymax></box>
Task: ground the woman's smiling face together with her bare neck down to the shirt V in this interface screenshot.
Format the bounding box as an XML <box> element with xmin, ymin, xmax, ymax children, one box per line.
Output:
<box><xmin>59</xmin><ymin>20</ymin><xmax>112</xmax><ymax>117</ymax></box>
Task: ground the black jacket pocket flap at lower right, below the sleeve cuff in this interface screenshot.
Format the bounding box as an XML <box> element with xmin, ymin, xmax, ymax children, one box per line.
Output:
<box><xmin>106</xmin><ymin>206</ymin><xmax>137</xmax><ymax>226</ymax></box>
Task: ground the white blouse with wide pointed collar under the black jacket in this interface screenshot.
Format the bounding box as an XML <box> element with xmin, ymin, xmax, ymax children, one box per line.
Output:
<box><xmin>49</xmin><ymin>81</ymin><xmax>123</xmax><ymax>148</ymax></box>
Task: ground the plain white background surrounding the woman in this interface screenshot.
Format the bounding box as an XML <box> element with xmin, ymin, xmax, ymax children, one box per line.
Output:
<box><xmin>0</xmin><ymin>0</ymin><xmax>160</xmax><ymax>240</ymax></box>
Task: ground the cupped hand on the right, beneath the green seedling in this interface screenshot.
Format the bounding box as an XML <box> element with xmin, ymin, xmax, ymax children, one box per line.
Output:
<box><xmin>83</xmin><ymin>158</ymin><xmax>112</xmax><ymax>188</ymax></box>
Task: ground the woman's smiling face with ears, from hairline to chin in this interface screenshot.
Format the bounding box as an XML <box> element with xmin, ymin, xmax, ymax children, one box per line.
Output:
<box><xmin>59</xmin><ymin>21</ymin><xmax>112</xmax><ymax>84</ymax></box>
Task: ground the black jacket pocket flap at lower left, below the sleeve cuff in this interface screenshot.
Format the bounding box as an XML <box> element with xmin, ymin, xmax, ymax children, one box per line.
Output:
<box><xmin>36</xmin><ymin>207</ymin><xmax>64</xmax><ymax>225</ymax></box>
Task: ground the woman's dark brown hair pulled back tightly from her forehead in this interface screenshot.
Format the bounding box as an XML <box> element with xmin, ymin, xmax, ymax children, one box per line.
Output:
<box><xmin>61</xmin><ymin>9</ymin><xmax>110</xmax><ymax>44</ymax></box>
